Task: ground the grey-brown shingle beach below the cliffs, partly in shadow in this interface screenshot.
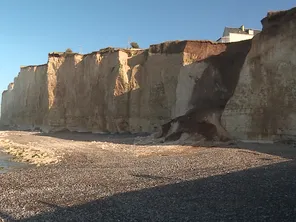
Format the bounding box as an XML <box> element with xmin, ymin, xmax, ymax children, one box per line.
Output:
<box><xmin>0</xmin><ymin>131</ymin><xmax>296</xmax><ymax>221</ymax></box>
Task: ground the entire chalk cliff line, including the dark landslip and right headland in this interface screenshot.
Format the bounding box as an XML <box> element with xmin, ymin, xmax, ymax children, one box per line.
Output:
<box><xmin>1</xmin><ymin>8</ymin><xmax>296</xmax><ymax>143</ymax></box>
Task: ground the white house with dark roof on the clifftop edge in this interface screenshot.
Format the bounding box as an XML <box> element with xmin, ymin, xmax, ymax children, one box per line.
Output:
<box><xmin>217</xmin><ymin>25</ymin><xmax>260</xmax><ymax>43</ymax></box>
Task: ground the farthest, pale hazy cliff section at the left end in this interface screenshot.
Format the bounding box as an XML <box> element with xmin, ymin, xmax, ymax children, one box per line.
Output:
<box><xmin>1</xmin><ymin>65</ymin><xmax>48</xmax><ymax>129</ymax></box>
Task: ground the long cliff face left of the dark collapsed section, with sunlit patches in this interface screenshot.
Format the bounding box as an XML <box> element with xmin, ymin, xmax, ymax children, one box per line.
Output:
<box><xmin>2</xmin><ymin>41</ymin><xmax>234</xmax><ymax>132</ymax></box>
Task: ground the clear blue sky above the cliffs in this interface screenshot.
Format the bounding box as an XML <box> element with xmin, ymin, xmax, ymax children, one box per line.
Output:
<box><xmin>0</xmin><ymin>0</ymin><xmax>295</xmax><ymax>96</ymax></box>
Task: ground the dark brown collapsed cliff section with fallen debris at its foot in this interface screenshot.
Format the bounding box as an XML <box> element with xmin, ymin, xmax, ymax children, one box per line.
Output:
<box><xmin>159</xmin><ymin>40</ymin><xmax>251</xmax><ymax>141</ymax></box>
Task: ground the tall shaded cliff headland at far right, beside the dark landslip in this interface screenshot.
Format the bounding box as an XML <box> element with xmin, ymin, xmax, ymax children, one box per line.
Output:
<box><xmin>222</xmin><ymin>8</ymin><xmax>296</xmax><ymax>141</ymax></box>
